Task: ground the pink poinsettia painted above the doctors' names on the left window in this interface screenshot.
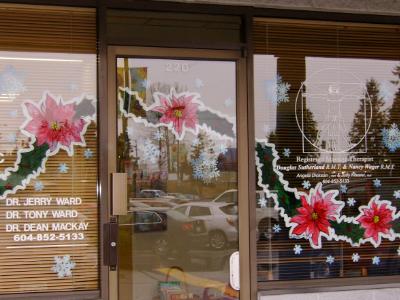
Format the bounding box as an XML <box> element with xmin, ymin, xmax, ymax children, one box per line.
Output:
<box><xmin>23</xmin><ymin>95</ymin><xmax>85</xmax><ymax>152</ymax></box>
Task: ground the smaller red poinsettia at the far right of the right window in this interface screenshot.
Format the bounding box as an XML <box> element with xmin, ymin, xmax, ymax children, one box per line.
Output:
<box><xmin>355</xmin><ymin>196</ymin><xmax>396</xmax><ymax>247</ymax></box>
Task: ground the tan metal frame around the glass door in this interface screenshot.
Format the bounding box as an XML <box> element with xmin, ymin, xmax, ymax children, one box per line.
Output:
<box><xmin>106</xmin><ymin>46</ymin><xmax>250</xmax><ymax>300</ymax></box>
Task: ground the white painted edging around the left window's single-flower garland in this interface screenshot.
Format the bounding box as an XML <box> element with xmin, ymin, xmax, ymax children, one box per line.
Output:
<box><xmin>0</xmin><ymin>91</ymin><xmax>96</xmax><ymax>199</ymax></box>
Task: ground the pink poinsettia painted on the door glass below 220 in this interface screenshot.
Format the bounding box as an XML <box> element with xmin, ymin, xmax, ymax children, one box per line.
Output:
<box><xmin>152</xmin><ymin>89</ymin><xmax>199</xmax><ymax>138</ymax></box>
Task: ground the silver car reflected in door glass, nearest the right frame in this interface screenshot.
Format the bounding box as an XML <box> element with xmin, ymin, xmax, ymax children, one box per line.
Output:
<box><xmin>174</xmin><ymin>202</ymin><xmax>238</xmax><ymax>249</ymax></box>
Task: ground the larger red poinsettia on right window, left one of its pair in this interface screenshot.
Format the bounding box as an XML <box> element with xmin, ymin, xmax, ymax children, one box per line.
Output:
<box><xmin>290</xmin><ymin>184</ymin><xmax>344</xmax><ymax>248</ymax></box>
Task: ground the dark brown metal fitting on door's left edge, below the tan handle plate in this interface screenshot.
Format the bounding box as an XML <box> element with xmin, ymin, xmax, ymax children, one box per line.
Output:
<box><xmin>103</xmin><ymin>218</ymin><xmax>118</xmax><ymax>271</ymax></box>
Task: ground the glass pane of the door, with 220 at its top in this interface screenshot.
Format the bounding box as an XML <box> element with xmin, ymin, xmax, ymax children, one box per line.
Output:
<box><xmin>116</xmin><ymin>57</ymin><xmax>239</xmax><ymax>300</ymax></box>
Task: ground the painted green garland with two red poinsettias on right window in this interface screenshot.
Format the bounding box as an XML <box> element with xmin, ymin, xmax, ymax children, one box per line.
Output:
<box><xmin>256</xmin><ymin>139</ymin><xmax>400</xmax><ymax>249</ymax></box>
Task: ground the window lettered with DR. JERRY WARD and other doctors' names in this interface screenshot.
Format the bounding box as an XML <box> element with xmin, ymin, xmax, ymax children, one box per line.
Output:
<box><xmin>0</xmin><ymin>6</ymin><xmax>99</xmax><ymax>295</ymax></box>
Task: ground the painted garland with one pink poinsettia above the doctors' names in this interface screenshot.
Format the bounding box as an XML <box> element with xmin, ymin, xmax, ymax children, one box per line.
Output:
<box><xmin>0</xmin><ymin>92</ymin><xmax>96</xmax><ymax>199</ymax></box>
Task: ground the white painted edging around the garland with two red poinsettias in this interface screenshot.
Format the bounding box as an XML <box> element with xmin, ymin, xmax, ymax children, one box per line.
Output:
<box><xmin>255</xmin><ymin>139</ymin><xmax>400</xmax><ymax>249</ymax></box>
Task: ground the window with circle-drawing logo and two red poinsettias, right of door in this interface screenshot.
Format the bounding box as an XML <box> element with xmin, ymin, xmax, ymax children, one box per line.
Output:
<box><xmin>254</xmin><ymin>19</ymin><xmax>400</xmax><ymax>285</ymax></box>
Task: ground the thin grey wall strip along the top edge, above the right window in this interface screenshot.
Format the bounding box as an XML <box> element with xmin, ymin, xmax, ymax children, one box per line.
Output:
<box><xmin>159</xmin><ymin>0</ymin><xmax>400</xmax><ymax>15</ymax></box>
